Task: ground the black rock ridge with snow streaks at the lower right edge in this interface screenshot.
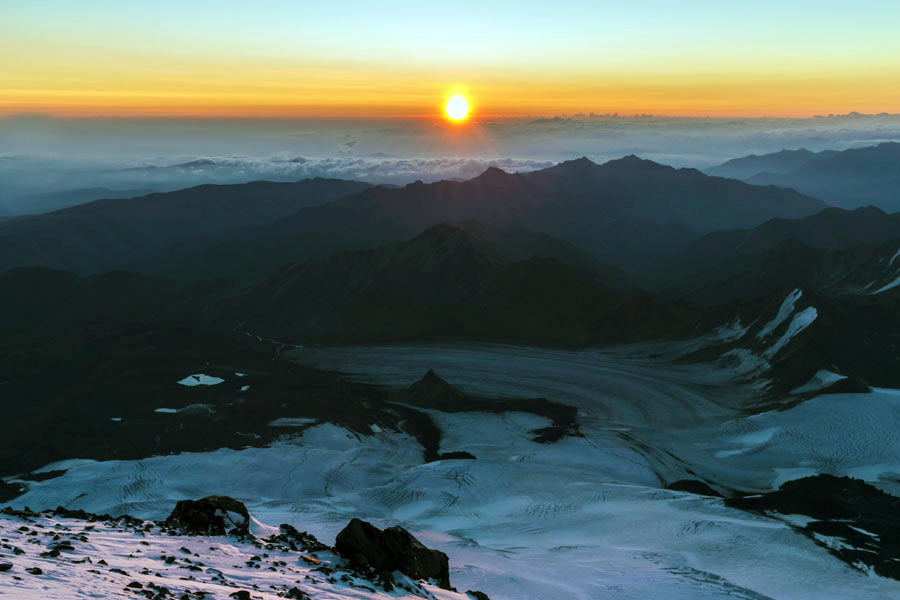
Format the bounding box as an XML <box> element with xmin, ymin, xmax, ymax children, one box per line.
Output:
<box><xmin>725</xmin><ymin>475</ymin><xmax>900</xmax><ymax>579</ymax></box>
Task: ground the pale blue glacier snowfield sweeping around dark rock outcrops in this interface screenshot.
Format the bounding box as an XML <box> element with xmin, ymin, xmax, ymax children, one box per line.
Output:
<box><xmin>7</xmin><ymin>344</ymin><xmax>900</xmax><ymax>600</ymax></box>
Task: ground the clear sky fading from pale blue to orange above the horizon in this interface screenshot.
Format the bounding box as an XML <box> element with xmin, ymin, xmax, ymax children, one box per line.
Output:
<box><xmin>0</xmin><ymin>0</ymin><xmax>900</xmax><ymax>119</ymax></box>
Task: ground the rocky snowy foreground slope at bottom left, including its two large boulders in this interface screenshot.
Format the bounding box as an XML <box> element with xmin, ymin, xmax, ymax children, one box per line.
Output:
<box><xmin>0</xmin><ymin>496</ymin><xmax>488</xmax><ymax>600</ymax></box>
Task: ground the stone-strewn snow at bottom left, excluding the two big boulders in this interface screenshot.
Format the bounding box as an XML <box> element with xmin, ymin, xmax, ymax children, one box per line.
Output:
<box><xmin>0</xmin><ymin>511</ymin><xmax>474</xmax><ymax>600</ymax></box>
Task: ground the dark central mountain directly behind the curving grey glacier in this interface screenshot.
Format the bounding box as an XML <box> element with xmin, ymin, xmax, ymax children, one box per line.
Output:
<box><xmin>234</xmin><ymin>225</ymin><xmax>694</xmax><ymax>345</ymax></box>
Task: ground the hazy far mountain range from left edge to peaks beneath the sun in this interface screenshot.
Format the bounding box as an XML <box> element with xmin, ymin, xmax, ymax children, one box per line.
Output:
<box><xmin>0</xmin><ymin>156</ymin><xmax>824</xmax><ymax>279</ymax></box>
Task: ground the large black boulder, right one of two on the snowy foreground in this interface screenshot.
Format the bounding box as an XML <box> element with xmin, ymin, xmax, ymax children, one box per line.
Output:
<box><xmin>334</xmin><ymin>519</ymin><xmax>450</xmax><ymax>589</ymax></box>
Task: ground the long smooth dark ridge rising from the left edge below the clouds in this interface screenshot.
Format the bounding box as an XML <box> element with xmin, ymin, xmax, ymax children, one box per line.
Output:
<box><xmin>0</xmin><ymin>179</ymin><xmax>369</xmax><ymax>273</ymax></box>
